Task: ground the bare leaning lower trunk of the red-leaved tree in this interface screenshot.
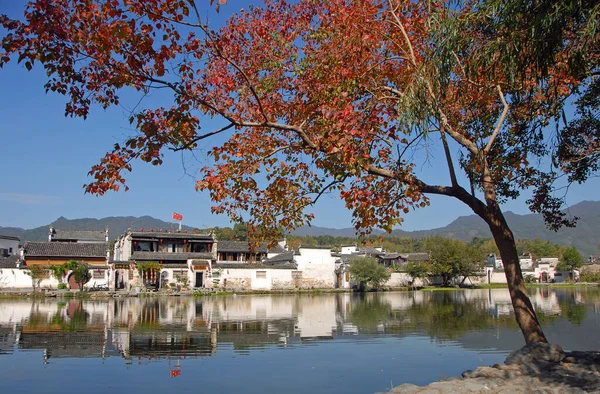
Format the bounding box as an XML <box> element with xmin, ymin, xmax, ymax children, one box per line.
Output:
<box><xmin>486</xmin><ymin>209</ymin><xmax>548</xmax><ymax>344</ymax></box>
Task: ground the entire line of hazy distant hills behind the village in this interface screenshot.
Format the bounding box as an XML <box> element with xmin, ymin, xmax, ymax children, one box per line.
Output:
<box><xmin>0</xmin><ymin>201</ymin><xmax>600</xmax><ymax>255</ymax></box>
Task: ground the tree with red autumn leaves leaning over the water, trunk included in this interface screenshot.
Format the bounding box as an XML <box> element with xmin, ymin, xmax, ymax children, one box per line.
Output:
<box><xmin>0</xmin><ymin>0</ymin><xmax>597</xmax><ymax>343</ymax></box>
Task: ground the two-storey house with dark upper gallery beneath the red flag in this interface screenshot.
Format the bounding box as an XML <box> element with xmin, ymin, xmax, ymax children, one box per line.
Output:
<box><xmin>110</xmin><ymin>228</ymin><xmax>217</xmax><ymax>289</ymax></box>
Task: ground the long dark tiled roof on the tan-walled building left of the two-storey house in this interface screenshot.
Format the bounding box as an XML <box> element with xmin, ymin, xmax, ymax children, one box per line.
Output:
<box><xmin>24</xmin><ymin>242</ymin><xmax>108</xmax><ymax>259</ymax></box>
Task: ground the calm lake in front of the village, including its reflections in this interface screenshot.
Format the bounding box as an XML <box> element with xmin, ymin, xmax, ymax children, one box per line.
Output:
<box><xmin>0</xmin><ymin>287</ymin><xmax>600</xmax><ymax>394</ymax></box>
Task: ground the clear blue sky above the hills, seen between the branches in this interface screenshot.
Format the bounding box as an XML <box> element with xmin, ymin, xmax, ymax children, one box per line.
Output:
<box><xmin>0</xmin><ymin>0</ymin><xmax>600</xmax><ymax>230</ymax></box>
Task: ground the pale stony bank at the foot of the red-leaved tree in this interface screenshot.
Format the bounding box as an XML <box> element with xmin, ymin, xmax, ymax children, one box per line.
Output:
<box><xmin>389</xmin><ymin>344</ymin><xmax>600</xmax><ymax>394</ymax></box>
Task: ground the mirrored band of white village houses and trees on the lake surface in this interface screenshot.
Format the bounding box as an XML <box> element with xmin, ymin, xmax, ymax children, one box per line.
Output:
<box><xmin>0</xmin><ymin>288</ymin><xmax>600</xmax><ymax>362</ymax></box>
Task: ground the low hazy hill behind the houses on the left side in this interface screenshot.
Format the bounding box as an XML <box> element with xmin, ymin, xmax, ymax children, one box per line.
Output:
<box><xmin>0</xmin><ymin>216</ymin><xmax>195</xmax><ymax>242</ymax></box>
